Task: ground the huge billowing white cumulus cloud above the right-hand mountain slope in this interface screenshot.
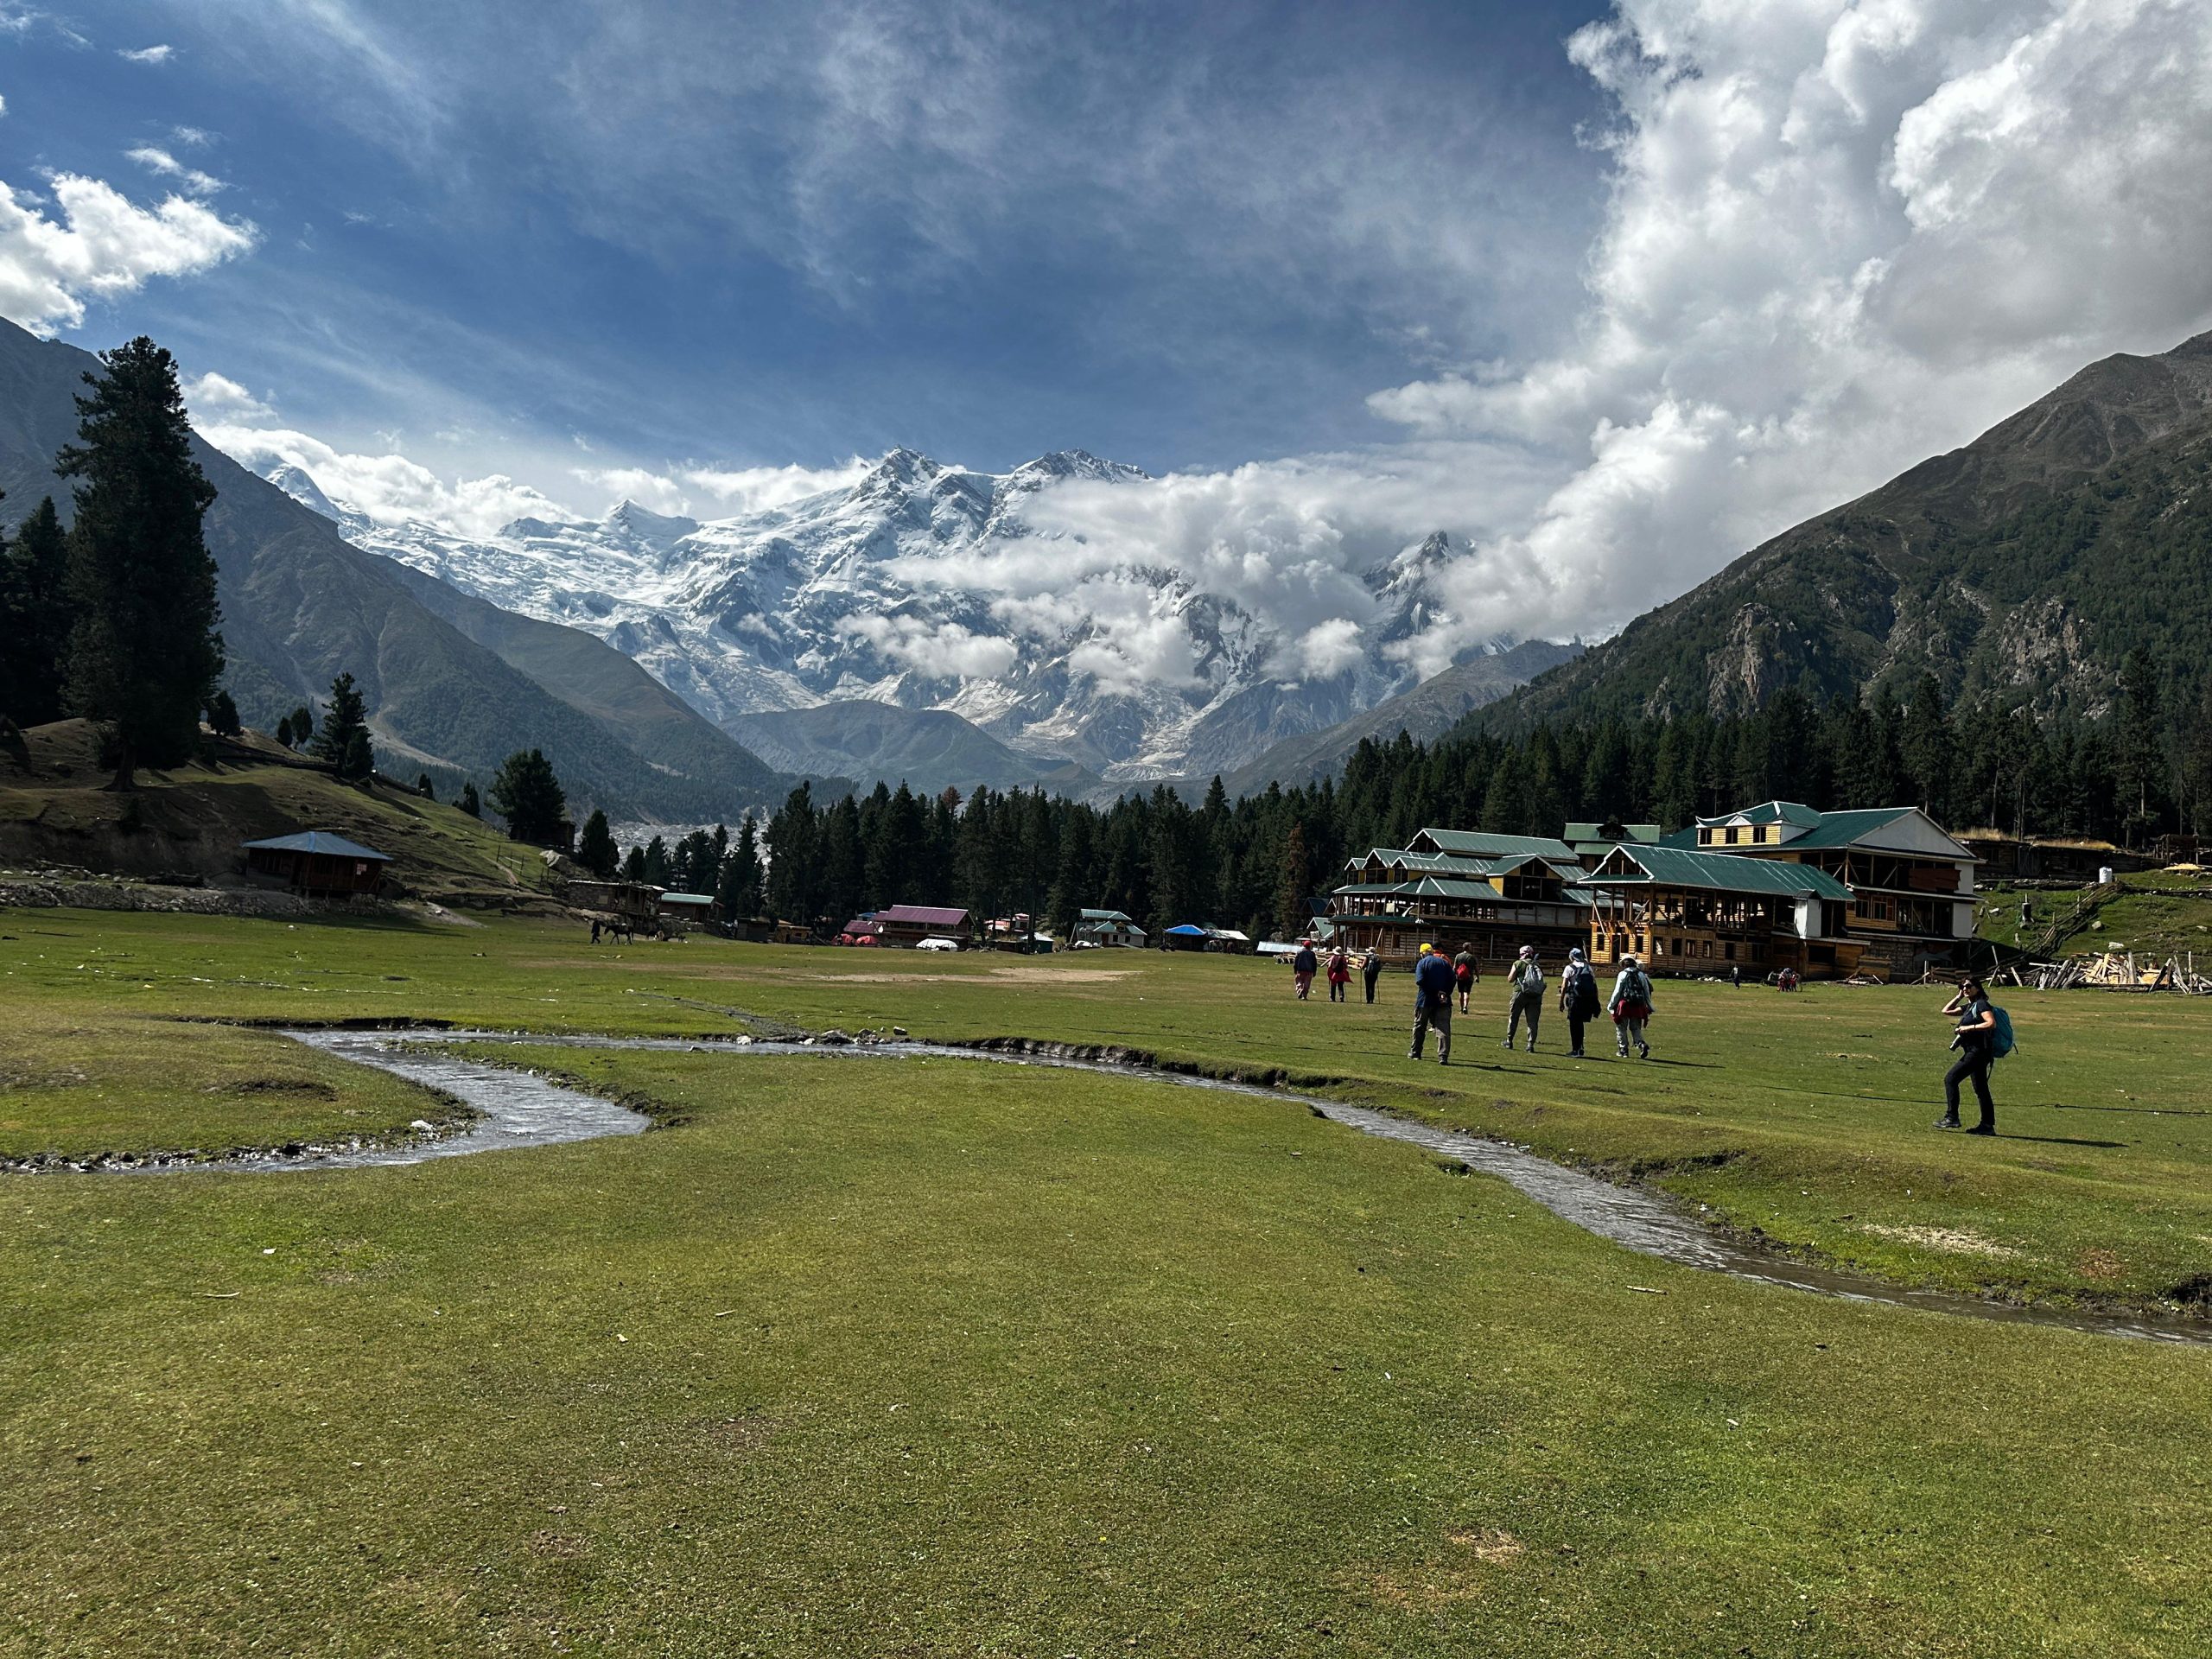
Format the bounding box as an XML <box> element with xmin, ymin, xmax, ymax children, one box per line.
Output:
<box><xmin>1370</xmin><ymin>0</ymin><xmax>2212</xmax><ymax>661</ymax></box>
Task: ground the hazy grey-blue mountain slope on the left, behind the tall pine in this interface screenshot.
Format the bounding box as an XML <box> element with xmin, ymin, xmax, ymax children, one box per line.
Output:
<box><xmin>0</xmin><ymin>323</ymin><xmax>785</xmax><ymax>821</ymax></box>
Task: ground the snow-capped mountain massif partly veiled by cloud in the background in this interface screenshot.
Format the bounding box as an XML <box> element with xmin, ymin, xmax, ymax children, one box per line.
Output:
<box><xmin>254</xmin><ymin>449</ymin><xmax>1503</xmax><ymax>781</ymax></box>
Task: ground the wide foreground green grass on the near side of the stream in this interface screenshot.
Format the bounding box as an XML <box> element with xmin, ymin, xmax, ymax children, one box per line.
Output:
<box><xmin>0</xmin><ymin>1052</ymin><xmax>2212</xmax><ymax>1656</ymax></box>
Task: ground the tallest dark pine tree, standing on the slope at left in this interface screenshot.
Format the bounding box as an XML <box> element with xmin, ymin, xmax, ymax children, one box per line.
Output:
<box><xmin>55</xmin><ymin>334</ymin><xmax>224</xmax><ymax>787</ymax></box>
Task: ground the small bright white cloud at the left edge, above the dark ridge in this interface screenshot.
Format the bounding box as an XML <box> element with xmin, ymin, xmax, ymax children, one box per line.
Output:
<box><xmin>0</xmin><ymin>173</ymin><xmax>259</xmax><ymax>329</ymax></box>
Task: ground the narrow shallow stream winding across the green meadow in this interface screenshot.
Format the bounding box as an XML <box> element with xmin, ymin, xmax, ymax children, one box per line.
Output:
<box><xmin>95</xmin><ymin>1031</ymin><xmax>2212</xmax><ymax>1343</ymax></box>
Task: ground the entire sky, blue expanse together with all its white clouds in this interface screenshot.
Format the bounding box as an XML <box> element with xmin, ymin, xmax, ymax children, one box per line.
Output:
<box><xmin>0</xmin><ymin>0</ymin><xmax>2212</xmax><ymax>664</ymax></box>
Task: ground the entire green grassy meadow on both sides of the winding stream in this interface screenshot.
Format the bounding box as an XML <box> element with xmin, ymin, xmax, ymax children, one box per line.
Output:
<box><xmin>0</xmin><ymin>912</ymin><xmax>2212</xmax><ymax>1655</ymax></box>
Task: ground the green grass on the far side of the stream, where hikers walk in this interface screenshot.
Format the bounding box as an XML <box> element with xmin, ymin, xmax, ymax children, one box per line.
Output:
<box><xmin>0</xmin><ymin>912</ymin><xmax>2212</xmax><ymax>1305</ymax></box>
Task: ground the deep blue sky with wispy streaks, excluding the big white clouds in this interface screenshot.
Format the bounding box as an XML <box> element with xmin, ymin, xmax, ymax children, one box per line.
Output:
<box><xmin>0</xmin><ymin>0</ymin><xmax>1604</xmax><ymax>493</ymax></box>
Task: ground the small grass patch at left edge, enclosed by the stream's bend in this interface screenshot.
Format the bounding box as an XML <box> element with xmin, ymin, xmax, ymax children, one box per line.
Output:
<box><xmin>0</xmin><ymin>1007</ymin><xmax>451</xmax><ymax>1157</ymax></box>
